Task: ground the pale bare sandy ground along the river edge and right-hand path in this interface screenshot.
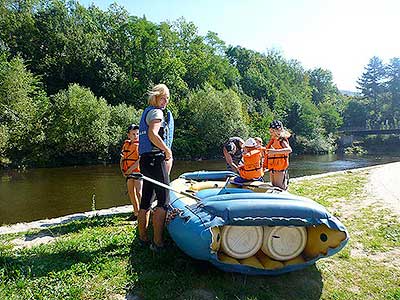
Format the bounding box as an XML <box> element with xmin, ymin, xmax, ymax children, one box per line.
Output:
<box><xmin>0</xmin><ymin>162</ymin><xmax>400</xmax><ymax>248</ymax></box>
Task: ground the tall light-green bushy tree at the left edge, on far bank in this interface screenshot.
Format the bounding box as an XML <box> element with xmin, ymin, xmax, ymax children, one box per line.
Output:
<box><xmin>0</xmin><ymin>56</ymin><xmax>49</xmax><ymax>164</ymax></box>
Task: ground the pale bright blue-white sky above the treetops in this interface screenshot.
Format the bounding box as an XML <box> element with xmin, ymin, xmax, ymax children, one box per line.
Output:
<box><xmin>79</xmin><ymin>0</ymin><xmax>400</xmax><ymax>91</ymax></box>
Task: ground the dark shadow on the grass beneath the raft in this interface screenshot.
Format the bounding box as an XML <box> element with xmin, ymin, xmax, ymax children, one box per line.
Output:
<box><xmin>127</xmin><ymin>233</ymin><xmax>323</xmax><ymax>299</ymax></box>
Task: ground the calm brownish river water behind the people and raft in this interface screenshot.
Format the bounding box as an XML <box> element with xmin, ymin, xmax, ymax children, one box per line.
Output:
<box><xmin>0</xmin><ymin>153</ymin><xmax>400</xmax><ymax>225</ymax></box>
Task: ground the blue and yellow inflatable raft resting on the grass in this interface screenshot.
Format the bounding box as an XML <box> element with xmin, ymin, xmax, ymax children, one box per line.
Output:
<box><xmin>168</xmin><ymin>171</ymin><xmax>349</xmax><ymax>275</ymax></box>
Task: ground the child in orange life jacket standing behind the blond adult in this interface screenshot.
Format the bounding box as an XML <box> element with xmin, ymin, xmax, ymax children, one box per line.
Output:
<box><xmin>119</xmin><ymin>124</ymin><xmax>142</xmax><ymax>221</ymax></box>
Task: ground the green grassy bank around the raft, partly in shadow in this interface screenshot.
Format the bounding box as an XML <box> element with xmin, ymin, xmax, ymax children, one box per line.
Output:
<box><xmin>0</xmin><ymin>171</ymin><xmax>400</xmax><ymax>300</ymax></box>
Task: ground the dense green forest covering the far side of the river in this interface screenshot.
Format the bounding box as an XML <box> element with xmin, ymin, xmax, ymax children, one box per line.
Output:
<box><xmin>0</xmin><ymin>0</ymin><xmax>400</xmax><ymax>166</ymax></box>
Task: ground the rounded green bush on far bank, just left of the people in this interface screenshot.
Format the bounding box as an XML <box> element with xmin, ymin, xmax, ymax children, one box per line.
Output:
<box><xmin>48</xmin><ymin>84</ymin><xmax>110</xmax><ymax>161</ymax></box>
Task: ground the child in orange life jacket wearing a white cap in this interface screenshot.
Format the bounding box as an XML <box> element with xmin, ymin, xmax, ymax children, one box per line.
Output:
<box><xmin>234</xmin><ymin>138</ymin><xmax>264</xmax><ymax>183</ymax></box>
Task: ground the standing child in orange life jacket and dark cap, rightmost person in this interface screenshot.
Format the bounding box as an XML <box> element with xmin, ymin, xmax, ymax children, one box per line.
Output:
<box><xmin>263</xmin><ymin>120</ymin><xmax>292</xmax><ymax>190</ymax></box>
